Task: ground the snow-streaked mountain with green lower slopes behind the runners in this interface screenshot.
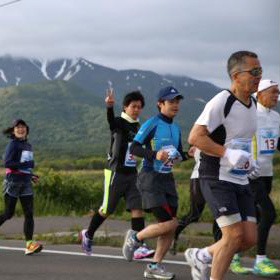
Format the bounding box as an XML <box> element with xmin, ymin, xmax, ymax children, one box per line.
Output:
<box><xmin>0</xmin><ymin>56</ymin><xmax>223</xmax><ymax>156</ymax></box>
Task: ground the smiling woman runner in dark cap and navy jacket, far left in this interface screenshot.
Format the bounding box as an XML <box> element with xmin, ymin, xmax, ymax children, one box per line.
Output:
<box><xmin>0</xmin><ymin>119</ymin><xmax>43</xmax><ymax>255</ymax></box>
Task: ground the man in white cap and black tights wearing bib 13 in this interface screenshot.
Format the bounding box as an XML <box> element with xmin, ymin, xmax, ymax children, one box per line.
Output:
<box><xmin>230</xmin><ymin>80</ymin><xmax>280</xmax><ymax>277</ymax></box>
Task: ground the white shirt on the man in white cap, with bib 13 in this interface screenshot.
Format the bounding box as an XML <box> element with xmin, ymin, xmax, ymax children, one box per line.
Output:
<box><xmin>253</xmin><ymin>103</ymin><xmax>280</xmax><ymax>176</ymax></box>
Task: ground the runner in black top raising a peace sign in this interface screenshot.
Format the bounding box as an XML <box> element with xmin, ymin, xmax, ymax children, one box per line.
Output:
<box><xmin>79</xmin><ymin>89</ymin><xmax>154</xmax><ymax>259</ymax></box>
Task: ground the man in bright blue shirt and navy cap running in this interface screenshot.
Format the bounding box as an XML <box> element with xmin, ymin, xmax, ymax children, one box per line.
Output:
<box><xmin>123</xmin><ymin>87</ymin><xmax>186</xmax><ymax>279</ymax></box>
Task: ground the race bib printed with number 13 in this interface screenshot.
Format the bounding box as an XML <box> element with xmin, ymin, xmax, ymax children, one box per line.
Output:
<box><xmin>259</xmin><ymin>128</ymin><xmax>278</xmax><ymax>155</ymax></box>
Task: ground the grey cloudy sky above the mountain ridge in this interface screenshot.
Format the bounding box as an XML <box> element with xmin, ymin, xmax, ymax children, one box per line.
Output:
<box><xmin>0</xmin><ymin>0</ymin><xmax>280</xmax><ymax>87</ymax></box>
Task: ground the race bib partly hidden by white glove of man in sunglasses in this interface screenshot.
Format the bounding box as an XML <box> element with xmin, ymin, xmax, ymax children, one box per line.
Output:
<box><xmin>227</xmin><ymin>138</ymin><xmax>251</xmax><ymax>176</ymax></box>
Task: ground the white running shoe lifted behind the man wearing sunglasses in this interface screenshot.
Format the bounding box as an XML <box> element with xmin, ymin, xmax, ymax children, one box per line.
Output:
<box><xmin>185</xmin><ymin>248</ymin><xmax>210</xmax><ymax>280</ymax></box>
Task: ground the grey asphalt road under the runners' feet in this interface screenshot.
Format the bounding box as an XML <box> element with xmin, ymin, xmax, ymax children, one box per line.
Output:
<box><xmin>0</xmin><ymin>240</ymin><xmax>279</xmax><ymax>280</ymax></box>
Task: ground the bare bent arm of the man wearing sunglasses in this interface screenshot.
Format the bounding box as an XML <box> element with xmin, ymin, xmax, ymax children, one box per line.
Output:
<box><xmin>188</xmin><ymin>124</ymin><xmax>226</xmax><ymax>157</ymax></box>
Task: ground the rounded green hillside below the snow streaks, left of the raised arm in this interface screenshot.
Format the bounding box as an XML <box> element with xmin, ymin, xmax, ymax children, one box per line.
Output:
<box><xmin>0</xmin><ymin>81</ymin><xmax>111</xmax><ymax>158</ymax></box>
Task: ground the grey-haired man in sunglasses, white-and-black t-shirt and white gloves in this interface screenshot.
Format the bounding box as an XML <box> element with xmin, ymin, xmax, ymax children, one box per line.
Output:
<box><xmin>185</xmin><ymin>51</ymin><xmax>262</xmax><ymax>280</ymax></box>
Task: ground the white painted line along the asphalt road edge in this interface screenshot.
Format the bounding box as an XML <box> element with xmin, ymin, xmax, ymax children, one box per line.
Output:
<box><xmin>0</xmin><ymin>246</ymin><xmax>187</xmax><ymax>265</ymax></box>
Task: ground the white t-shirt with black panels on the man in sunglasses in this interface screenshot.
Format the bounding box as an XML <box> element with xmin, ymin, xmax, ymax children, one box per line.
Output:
<box><xmin>196</xmin><ymin>90</ymin><xmax>257</xmax><ymax>185</ymax></box>
